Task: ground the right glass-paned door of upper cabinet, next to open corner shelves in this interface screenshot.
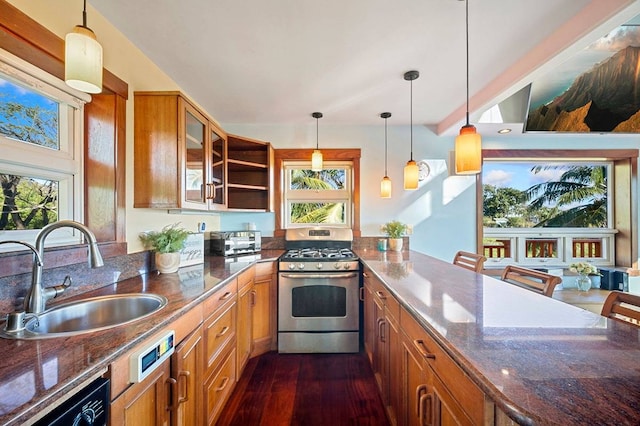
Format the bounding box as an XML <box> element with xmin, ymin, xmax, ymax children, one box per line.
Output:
<box><xmin>207</xmin><ymin>123</ymin><xmax>227</xmax><ymax>210</ymax></box>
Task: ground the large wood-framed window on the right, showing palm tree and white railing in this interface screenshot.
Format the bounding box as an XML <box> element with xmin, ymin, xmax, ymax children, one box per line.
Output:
<box><xmin>478</xmin><ymin>150</ymin><xmax>638</xmax><ymax>267</ymax></box>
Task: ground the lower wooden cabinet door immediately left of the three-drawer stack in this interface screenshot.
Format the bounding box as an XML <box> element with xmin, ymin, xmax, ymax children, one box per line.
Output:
<box><xmin>171</xmin><ymin>327</ymin><xmax>205</xmax><ymax>426</ymax></box>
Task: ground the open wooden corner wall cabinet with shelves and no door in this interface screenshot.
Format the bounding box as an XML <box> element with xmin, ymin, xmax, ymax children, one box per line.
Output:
<box><xmin>227</xmin><ymin>135</ymin><xmax>273</xmax><ymax>211</ymax></box>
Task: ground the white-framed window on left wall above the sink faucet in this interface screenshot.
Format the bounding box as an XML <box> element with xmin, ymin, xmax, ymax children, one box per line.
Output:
<box><xmin>0</xmin><ymin>51</ymin><xmax>89</xmax><ymax>251</ymax></box>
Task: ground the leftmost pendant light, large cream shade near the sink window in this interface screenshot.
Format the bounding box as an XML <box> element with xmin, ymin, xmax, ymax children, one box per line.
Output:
<box><xmin>64</xmin><ymin>0</ymin><xmax>102</xmax><ymax>93</ymax></box>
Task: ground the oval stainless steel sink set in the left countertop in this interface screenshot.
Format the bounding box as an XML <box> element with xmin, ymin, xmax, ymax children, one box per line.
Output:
<box><xmin>1</xmin><ymin>293</ymin><xmax>167</xmax><ymax>339</ymax></box>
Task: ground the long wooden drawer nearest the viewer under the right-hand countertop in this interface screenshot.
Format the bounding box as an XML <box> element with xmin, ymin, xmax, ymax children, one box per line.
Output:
<box><xmin>400</xmin><ymin>309</ymin><xmax>484</xmax><ymax>424</ymax></box>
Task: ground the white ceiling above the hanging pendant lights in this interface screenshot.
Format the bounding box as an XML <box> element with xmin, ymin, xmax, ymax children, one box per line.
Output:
<box><xmin>90</xmin><ymin>0</ymin><xmax>638</xmax><ymax>134</ymax></box>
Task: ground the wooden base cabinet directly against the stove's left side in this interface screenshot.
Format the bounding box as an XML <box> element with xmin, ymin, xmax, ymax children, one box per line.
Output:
<box><xmin>251</xmin><ymin>261</ymin><xmax>277</xmax><ymax>357</ymax></box>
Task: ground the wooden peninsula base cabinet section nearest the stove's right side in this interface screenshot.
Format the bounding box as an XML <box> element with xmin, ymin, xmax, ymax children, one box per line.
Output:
<box><xmin>363</xmin><ymin>270</ymin><xmax>402</xmax><ymax>424</ymax></box>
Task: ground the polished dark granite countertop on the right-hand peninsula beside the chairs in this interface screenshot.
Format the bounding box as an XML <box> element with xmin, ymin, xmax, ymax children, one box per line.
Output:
<box><xmin>357</xmin><ymin>250</ymin><xmax>640</xmax><ymax>425</ymax></box>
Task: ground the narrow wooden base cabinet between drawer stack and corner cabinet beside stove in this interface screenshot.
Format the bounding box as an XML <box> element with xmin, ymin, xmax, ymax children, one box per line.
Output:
<box><xmin>236</xmin><ymin>267</ymin><xmax>255</xmax><ymax>377</ymax></box>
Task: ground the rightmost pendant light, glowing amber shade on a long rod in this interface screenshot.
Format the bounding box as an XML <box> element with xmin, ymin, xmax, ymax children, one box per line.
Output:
<box><xmin>455</xmin><ymin>0</ymin><xmax>482</xmax><ymax>175</ymax></box>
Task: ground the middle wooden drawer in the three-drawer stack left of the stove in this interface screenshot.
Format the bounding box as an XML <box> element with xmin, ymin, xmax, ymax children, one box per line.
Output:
<box><xmin>203</xmin><ymin>302</ymin><xmax>236</xmax><ymax>374</ymax></box>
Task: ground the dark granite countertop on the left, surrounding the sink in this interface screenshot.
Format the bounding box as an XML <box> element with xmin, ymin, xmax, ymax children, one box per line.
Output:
<box><xmin>0</xmin><ymin>250</ymin><xmax>282</xmax><ymax>425</ymax></box>
